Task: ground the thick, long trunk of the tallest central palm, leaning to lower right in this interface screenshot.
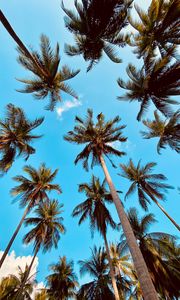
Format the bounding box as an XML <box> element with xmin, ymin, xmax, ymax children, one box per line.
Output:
<box><xmin>99</xmin><ymin>155</ymin><xmax>158</xmax><ymax>300</ymax></box>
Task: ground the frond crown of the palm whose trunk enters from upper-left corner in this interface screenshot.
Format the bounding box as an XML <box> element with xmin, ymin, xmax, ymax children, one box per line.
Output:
<box><xmin>18</xmin><ymin>35</ymin><xmax>80</xmax><ymax>110</ymax></box>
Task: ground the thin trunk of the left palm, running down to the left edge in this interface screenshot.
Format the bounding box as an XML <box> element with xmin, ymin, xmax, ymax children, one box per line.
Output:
<box><xmin>0</xmin><ymin>186</ymin><xmax>41</xmax><ymax>269</ymax></box>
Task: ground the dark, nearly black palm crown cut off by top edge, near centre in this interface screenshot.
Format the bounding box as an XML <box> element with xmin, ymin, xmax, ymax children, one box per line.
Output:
<box><xmin>62</xmin><ymin>0</ymin><xmax>132</xmax><ymax>71</ymax></box>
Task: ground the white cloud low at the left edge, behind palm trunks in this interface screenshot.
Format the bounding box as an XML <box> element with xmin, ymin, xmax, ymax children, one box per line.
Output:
<box><xmin>0</xmin><ymin>251</ymin><xmax>38</xmax><ymax>279</ymax></box>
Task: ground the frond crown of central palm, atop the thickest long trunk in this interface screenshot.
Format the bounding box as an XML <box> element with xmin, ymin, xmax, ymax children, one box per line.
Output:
<box><xmin>64</xmin><ymin>109</ymin><xmax>127</xmax><ymax>170</ymax></box>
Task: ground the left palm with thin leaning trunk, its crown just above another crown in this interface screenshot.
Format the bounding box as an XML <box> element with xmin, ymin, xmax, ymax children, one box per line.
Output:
<box><xmin>0</xmin><ymin>164</ymin><xmax>61</xmax><ymax>268</ymax></box>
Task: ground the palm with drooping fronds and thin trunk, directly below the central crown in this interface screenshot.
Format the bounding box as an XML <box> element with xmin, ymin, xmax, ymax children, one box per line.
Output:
<box><xmin>72</xmin><ymin>175</ymin><xmax>120</xmax><ymax>300</ymax></box>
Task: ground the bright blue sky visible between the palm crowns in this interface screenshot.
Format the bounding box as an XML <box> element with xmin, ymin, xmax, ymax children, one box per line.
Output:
<box><xmin>0</xmin><ymin>0</ymin><xmax>180</xmax><ymax>288</ymax></box>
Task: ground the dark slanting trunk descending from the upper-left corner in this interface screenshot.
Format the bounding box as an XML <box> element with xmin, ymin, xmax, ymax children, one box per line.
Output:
<box><xmin>0</xmin><ymin>10</ymin><xmax>46</xmax><ymax>77</ymax></box>
